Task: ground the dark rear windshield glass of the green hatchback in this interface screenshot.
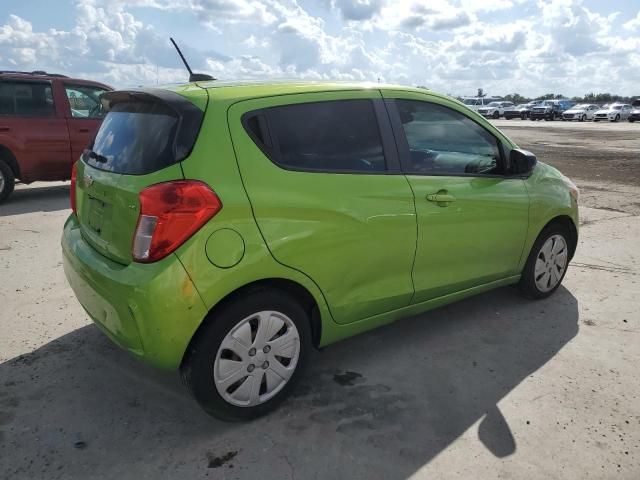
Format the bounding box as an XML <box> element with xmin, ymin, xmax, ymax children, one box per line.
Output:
<box><xmin>83</xmin><ymin>102</ymin><xmax>181</xmax><ymax>175</ymax></box>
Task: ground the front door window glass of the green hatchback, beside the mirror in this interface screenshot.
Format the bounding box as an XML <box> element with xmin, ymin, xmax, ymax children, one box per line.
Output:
<box><xmin>396</xmin><ymin>100</ymin><xmax>501</xmax><ymax>175</ymax></box>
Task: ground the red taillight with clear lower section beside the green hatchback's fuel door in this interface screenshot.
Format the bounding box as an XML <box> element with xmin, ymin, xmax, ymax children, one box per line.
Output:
<box><xmin>132</xmin><ymin>180</ymin><xmax>222</xmax><ymax>263</ymax></box>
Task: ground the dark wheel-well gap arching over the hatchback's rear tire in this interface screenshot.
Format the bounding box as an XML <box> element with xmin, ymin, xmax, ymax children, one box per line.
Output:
<box><xmin>182</xmin><ymin>278</ymin><xmax>322</xmax><ymax>368</ymax></box>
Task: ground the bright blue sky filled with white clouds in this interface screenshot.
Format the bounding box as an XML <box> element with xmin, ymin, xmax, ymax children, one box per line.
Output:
<box><xmin>0</xmin><ymin>0</ymin><xmax>640</xmax><ymax>96</ymax></box>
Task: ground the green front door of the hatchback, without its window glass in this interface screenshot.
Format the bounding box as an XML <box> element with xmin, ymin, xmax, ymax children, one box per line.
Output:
<box><xmin>383</xmin><ymin>91</ymin><xmax>529</xmax><ymax>303</ymax></box>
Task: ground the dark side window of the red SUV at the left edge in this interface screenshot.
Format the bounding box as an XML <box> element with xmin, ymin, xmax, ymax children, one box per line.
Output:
<box><xmin>0</xmin><ymin>80</ymin><xmax>55</xmax><ymax>117</ymax></box>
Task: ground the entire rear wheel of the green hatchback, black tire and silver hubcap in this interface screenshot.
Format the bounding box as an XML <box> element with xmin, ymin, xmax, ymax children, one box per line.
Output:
<box><xmin>181</xmin><ymin>289</ymin><xmax>311</xmax><ymax>421</ymax></box>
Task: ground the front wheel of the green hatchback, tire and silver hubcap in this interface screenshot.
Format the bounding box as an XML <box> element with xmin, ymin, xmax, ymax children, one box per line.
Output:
<box><xmin>518</xmin><ymin>224</ymin><xmax>571</xmax><ymax>300</ymax></box>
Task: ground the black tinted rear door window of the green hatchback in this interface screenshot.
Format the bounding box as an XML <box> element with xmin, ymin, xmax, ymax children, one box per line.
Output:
<box><xmin>260</xmin><ymin>100</ymin><xmax>386</xmax><ymax>173</ymax></box>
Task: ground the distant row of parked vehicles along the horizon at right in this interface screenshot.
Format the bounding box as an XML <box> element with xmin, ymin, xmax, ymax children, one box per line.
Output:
<box><xmin>463</xmin><ymin>99</ymin><xmax>640</xmax><ymax>123</ymax></box>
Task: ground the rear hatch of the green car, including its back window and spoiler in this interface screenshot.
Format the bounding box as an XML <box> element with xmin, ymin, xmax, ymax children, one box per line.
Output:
<box><xmin>76</xmin><ymin>89</ymin><xmax>206</xmax><ymax>265</ymax></box>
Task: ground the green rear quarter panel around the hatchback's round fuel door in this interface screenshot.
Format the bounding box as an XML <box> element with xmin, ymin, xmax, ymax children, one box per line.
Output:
<box><xmin>176</xmin><ymin>90</ymin><xmax>334</xmax><ymax>332</ymax></box>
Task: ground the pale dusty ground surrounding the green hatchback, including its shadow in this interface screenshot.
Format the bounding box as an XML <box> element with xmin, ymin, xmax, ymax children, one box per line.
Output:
<box><xmin>0</xmin><ymin>124</ymin><xmax>640</xmax><ymax>480</ymax></box>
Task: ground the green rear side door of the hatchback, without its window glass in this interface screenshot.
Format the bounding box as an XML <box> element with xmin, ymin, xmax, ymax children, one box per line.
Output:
<box><xmin>229</xmin><ymin>90</ymin><xmax>416</xmax><ymax>323</ymax></box>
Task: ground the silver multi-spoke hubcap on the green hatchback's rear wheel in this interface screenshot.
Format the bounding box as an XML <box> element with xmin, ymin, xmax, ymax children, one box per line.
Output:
<box><xmin>213</xmin><ymin>311</ymin><xmax>300</xmax><ymax>407</ymax></box>
